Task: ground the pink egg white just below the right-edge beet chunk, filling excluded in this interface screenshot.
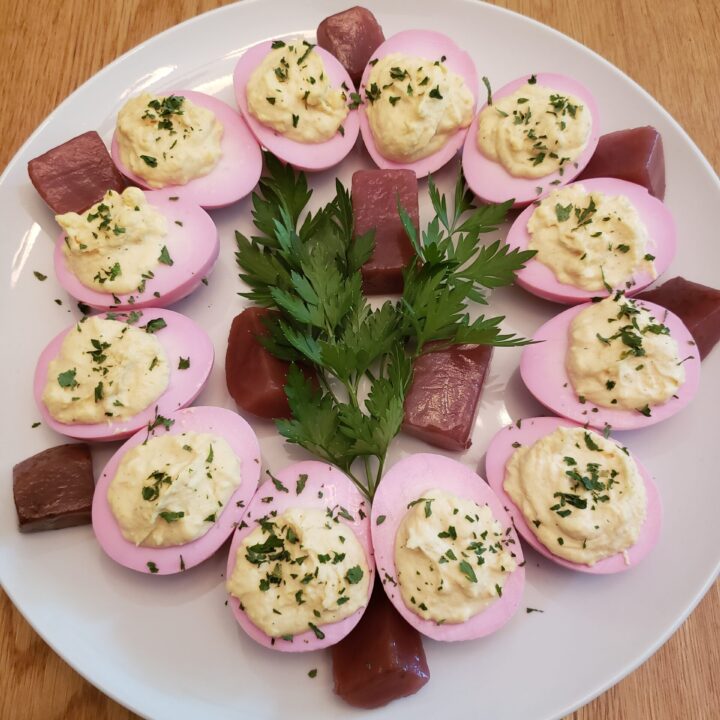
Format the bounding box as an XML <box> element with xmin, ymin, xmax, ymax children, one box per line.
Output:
<box><xmin>520</xmin><ymin>301</ymin><xmax>700</xmax><ymax>430</ymax></box>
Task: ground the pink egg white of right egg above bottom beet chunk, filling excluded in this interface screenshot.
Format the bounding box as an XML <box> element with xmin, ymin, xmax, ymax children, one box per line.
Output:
<box><xmin>371</xmin><ymin>453</ymin><xmax>525</xmax><ymax>642</ymax></box>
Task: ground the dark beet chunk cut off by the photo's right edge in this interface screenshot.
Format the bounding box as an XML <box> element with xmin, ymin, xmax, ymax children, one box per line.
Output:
<box><xmin>635</xmin><ymin>277</ymin><xmax>720</xmax><ymax>360</ymax></box>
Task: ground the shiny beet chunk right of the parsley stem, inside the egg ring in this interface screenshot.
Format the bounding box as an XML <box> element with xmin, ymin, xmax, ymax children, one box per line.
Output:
<box><xmin>403</xmin><ymin>343</ymin><xmax>492</xmax><ymax>450</ymax></box>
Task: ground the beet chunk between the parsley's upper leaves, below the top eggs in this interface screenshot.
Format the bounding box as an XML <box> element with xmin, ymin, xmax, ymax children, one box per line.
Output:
<box><xmin>352</xmin><ymin>170</ymin><xmax>419</xmax><ymax>295</ymax></box>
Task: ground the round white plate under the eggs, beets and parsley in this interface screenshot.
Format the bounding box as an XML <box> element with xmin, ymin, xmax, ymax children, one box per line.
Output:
<box><xmin>0</xmin><ymin>0</ymin><xmax>720</xmax><ymax>720</ymax></box>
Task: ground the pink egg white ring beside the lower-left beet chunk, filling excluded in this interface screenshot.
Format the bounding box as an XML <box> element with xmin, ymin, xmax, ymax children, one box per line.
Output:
<box><xmin>92</xmin><ymin>407</ymin><xmax>260</xmax><ymax>575</ymax></box>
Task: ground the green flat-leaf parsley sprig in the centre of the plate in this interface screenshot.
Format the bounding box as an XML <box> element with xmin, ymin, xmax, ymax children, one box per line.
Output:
<box><xmin>235</xmin><ymin>154</ymin><xmax>534</xmax><ymax>498</ymax></box>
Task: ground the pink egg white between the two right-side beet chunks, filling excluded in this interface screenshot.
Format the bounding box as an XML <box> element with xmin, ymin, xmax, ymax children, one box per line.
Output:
<box><xmin>507</xmin><ymin>178</ymin><xmax>677</xmax><ymax>304</ymax></box>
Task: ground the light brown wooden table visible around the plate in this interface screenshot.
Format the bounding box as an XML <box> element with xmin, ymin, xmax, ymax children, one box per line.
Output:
<box><xmin>0</xmin><ymin>0</ymin><xmax>720</xmax><ymax>720</ymax></box>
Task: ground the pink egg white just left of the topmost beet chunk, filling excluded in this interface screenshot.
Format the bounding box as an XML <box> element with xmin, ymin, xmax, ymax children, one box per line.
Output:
<box><xmin>233</xmin><ymin>40</ymin><xmax>360</xmax><ymax>171</ymax></box>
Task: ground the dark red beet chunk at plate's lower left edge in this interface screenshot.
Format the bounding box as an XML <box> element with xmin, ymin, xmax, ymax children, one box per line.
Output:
<box><xmin>13</xmin><ymin>443</ymin><xmax>95</xmax><ymax>532</ymax></box>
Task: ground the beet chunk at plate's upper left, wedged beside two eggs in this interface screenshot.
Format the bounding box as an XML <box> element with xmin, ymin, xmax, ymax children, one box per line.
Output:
<box><xmin>28</xmin><ymin>130</ymin><xmax>126</xmax><ymax>215</ymax></box>
